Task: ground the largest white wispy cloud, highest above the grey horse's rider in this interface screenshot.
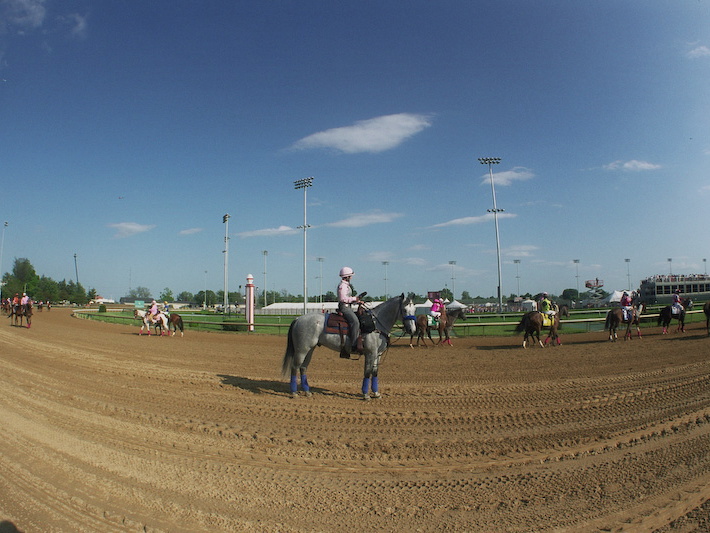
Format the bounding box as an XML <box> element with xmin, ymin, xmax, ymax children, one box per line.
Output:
<box><xmin>291</xmin><ymin>113</ymin><xmax>431</xmax><ymax>154</ymax></box>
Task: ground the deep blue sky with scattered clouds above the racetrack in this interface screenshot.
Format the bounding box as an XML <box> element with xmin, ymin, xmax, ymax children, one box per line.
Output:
<box><xmin>0</xmin><ymin>0</ymin><xmax>710</xmax><ymax>298</ymax></box>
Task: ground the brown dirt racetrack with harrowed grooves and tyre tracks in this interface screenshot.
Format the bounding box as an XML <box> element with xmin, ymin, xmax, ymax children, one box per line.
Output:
<box><xmin>0</xmin><ymin>309</ymin><xmax>710</xmax><ymax>533</ymax></box>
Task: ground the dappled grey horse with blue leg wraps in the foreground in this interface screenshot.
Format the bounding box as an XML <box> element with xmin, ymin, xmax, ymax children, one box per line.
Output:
<box><xmin>281</xmin><ymin>294</ymin><xmax>406</xmax><ymax>400</ymax></box>
